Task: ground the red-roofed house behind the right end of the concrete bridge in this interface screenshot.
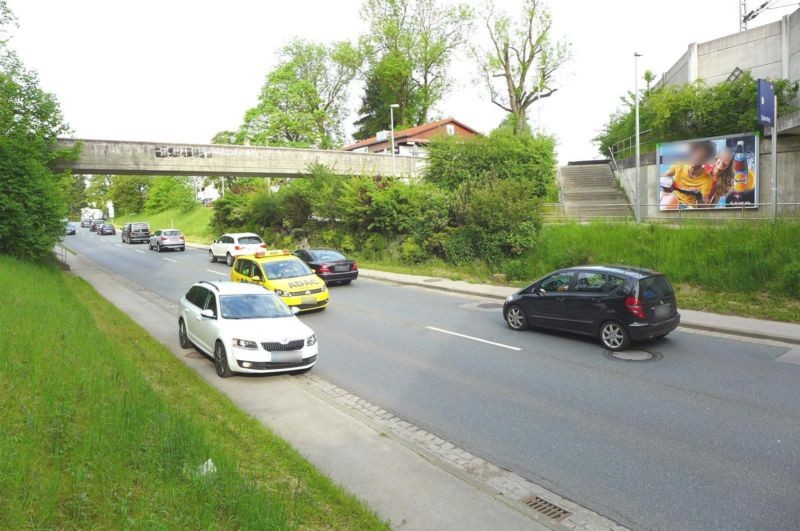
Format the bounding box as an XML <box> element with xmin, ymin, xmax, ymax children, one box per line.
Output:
<box><xmin>342</xmin><ymin>118</ymin><xmax>480</xmax><ymax>157</ymax></box>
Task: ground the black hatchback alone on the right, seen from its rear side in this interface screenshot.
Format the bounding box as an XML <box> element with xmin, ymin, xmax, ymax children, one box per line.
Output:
<box><xmin>503</xmin><ymin>266</ymin><xmax>680</xmax><ymax>351</ymax></box>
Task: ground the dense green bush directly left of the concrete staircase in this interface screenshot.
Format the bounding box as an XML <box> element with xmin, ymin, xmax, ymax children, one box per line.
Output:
<box><xmin>425</xmin><ymin>128</ymin><xmax>556</xmax><ymax>197</ymax></box>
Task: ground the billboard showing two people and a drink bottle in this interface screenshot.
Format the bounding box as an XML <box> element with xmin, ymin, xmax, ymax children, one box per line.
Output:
<box><xmin>656</xmin><ymin>133</ymin><xmax>759</xmax><ymax>210</ymax></box>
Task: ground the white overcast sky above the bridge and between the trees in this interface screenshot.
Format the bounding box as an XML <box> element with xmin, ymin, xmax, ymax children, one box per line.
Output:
<box><xmin>4</xmin><ymin>0</ymin><xmax>793</xmax><ymax>162</ymax></box>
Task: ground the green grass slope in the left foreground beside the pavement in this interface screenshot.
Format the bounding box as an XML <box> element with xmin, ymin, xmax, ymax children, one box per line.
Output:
<box><xmin>0</xmin><ymin>257</ymin><xmax>386</xmax><ymax>529</ymax></box>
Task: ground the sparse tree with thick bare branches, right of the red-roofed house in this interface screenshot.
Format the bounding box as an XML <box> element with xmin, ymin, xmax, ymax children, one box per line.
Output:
<box><xmin>476</xmin><ymin>0</ymin><xmax>568</xmax><ymax>132</ymax></box>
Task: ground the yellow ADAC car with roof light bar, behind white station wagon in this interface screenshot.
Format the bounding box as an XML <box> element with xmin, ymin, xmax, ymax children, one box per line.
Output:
<box><xmin>231</xmin><ymin>250</ymin><xmax>329</xmax><ymax>312</ymax></box>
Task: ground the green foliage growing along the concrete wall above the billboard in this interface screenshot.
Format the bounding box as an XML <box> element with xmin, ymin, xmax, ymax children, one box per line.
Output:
<box><xmin>595</xmin><ymin>72</ymin><xmax>798</xmax><ymax>156</ymax></box>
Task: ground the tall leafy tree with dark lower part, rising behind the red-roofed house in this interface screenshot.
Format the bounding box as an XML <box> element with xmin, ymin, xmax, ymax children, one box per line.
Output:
<box><xmin>353</xmin><ymin>0</ymin><xmax>472</xmax><ymax>139</ymax></box>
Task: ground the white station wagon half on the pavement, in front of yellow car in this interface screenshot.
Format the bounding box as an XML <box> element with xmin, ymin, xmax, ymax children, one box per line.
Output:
<box><xmin>178</xmin><ymin>281</ymin><xmax>318</xmax><ymax>378</ymax></box>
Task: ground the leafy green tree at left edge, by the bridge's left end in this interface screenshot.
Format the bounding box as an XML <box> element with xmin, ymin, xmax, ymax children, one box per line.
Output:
<box><xmin>0</xmin><ymin>46</ymin><xmax>77</xmax><ymax>260</ymax></box>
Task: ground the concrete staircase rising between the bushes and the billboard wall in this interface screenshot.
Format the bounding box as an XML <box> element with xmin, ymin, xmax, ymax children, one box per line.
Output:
<box><xmin>558</xmin><ymin>161</ymin><xmax>632</xmax><ymax>220</ymax></box>
